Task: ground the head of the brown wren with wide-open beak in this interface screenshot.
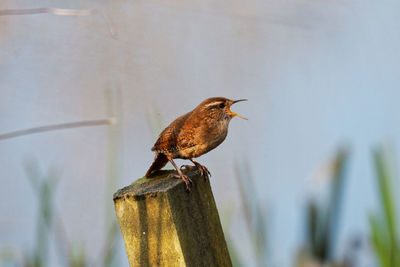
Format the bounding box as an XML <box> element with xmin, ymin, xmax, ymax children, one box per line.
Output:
<box><xmin>196</xmin><ymin>97</ymin><xmax>247</xmax><ymax>120</ymax></box>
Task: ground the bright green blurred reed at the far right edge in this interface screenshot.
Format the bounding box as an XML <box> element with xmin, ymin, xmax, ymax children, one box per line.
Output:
<box><xmin>369</xmin><ymin>147</ymin><xmax>400</xmax><ymax>267</ymax></box>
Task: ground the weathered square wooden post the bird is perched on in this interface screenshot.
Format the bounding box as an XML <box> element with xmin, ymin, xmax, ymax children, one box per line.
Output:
<box><xmin>114</xmin><ymin>171</ymin><xmax>232</xmax><ymax>267</ymax></box>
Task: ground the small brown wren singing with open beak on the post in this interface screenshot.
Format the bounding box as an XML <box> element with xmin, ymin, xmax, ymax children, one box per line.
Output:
<box><xmin>146</xmin><ymin>97</ymin><xmax>247</xmax><ymax>191</ymax></box>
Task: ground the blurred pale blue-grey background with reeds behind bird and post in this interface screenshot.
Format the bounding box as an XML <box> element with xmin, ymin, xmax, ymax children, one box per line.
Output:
<box><xmin>0</xmin><ymin>0</ymin><xmax>400</xmax><ymax>267</ymax></box>
